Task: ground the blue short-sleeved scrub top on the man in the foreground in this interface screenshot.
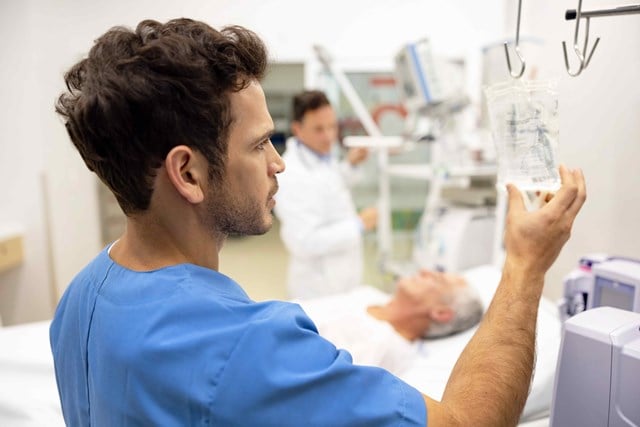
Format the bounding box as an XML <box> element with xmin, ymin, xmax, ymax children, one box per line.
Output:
<box><xmin>50</xmin><ymin>249</ymin><xmax>426</xmax><ymax>427</ymax></box>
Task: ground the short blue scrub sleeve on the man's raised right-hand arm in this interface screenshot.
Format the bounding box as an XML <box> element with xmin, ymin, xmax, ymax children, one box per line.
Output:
<box><xmin>211</xmin><ymin>304</ymin><xmax>426</xmax><ymax>427</ymax></box>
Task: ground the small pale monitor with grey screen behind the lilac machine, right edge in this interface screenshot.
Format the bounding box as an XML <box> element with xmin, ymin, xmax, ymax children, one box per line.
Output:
<box><xmin>590</xmin><ymin>259</ymin><xmax>640</xmax><ymax>312</ymax></box>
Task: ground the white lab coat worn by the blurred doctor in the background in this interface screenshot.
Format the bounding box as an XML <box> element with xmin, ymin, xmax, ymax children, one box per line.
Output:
<box><xmin>275</xmin><ymin>138</ymin><xmax>363</xmax><ymax>299</ymax></box>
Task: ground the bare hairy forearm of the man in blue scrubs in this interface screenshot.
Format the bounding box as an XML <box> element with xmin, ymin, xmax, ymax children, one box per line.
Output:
<box><xmin>442</xmin><ymin>260</ymin><xmax>544</xmax><ymax>427</ymax></box>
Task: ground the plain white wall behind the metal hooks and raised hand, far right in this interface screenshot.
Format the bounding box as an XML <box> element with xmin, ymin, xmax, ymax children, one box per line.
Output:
<box><xmin>505</xmin><ymin>0</ymin><xmax>640</xmax><ymax>298</ymax></box>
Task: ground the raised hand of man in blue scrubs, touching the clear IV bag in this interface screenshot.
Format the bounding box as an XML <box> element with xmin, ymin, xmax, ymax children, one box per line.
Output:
<box><xmin>504</xmin><ymin>165</ymin><xmax>587</xmax><ymax>278</ymax></box>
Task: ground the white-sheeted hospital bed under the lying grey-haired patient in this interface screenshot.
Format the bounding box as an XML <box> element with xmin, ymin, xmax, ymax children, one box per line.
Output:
<box><xmin>0</xmin><ymin>266</ymin><xmax>560</xmax><ymax>427</ymax></box>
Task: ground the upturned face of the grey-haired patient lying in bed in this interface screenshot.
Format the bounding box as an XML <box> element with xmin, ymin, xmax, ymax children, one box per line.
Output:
<box><xmin>396</xmin><ymin>270</ymin><xmax>467</xmax><ymax>308</ymax></box>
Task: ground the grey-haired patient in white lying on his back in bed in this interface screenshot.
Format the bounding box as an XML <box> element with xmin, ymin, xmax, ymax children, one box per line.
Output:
<box><xmin>300</xmin><ymin>270</ymin><xmax>483</xmax><ymax>375</ymax></box>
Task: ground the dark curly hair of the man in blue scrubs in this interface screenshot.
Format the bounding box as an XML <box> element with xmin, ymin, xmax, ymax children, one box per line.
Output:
<box><xmin>56</xmin><ymin>18</ymin><xmax>267</xmax><ymax>215</ymax></box>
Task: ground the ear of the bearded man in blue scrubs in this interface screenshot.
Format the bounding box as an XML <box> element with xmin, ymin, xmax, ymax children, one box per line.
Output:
<box><xmin>164</xmin><ymin>145</ymin><xmax>209</xmax><ymax>204</ymax></box>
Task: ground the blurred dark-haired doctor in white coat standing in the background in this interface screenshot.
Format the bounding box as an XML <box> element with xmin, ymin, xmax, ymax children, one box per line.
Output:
<box><xmin>275</xmin><ymin>91</ymin><xmax>377</xmax><ymax>299</ymax></box>
